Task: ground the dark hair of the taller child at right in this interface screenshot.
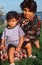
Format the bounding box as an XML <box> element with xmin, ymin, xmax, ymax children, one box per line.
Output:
<box><xmin>20</xmin><ymin>0</ymin><xmax>37</xmax><ymax>13</ymax></box>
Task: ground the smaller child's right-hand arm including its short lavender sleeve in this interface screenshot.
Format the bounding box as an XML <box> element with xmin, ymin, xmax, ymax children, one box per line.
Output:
<box><xmin>16</xmin><ymin>26</ymin><xmax>25</xmax><ymax>51</ymax></box>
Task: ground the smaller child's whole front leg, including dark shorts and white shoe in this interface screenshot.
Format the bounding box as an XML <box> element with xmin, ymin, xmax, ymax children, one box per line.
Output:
<box><xmin>8</xmin><ymin>44</ymin><xmax>16</xmax><ymax>65</ymax></box>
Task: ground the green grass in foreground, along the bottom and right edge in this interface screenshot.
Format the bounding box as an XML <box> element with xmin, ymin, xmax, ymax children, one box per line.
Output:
<box><xmin>0</xmin><ymin>26</ymin><xmax>42</xmax><ymax>65</ymax></box>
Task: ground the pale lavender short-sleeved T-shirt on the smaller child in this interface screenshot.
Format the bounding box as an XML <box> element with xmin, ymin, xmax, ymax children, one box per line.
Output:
<box><xmin>1</xmin><ymin>25</ymin><xmax>25</xmax><ymax>47</ymax></box>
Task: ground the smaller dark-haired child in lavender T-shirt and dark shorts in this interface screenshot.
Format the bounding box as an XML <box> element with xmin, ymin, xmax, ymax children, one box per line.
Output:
<box><xmin>1</xmin><ymin>11</ymin><xmax>24</xmax><ymax>65</ymax></box>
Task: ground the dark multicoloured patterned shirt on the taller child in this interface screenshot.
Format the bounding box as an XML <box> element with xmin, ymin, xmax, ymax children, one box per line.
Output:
<box><xmin>20</xmin><ymin>16</ymin><xmax>41</xmax><ymax>39</ymax></box>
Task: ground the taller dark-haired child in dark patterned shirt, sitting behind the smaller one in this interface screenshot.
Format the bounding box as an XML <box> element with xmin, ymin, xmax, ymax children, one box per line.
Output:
<box><xmin>20</xmin><ymin>0</ymin><xmax>41</xmax><ymax>58</ymax></box>
